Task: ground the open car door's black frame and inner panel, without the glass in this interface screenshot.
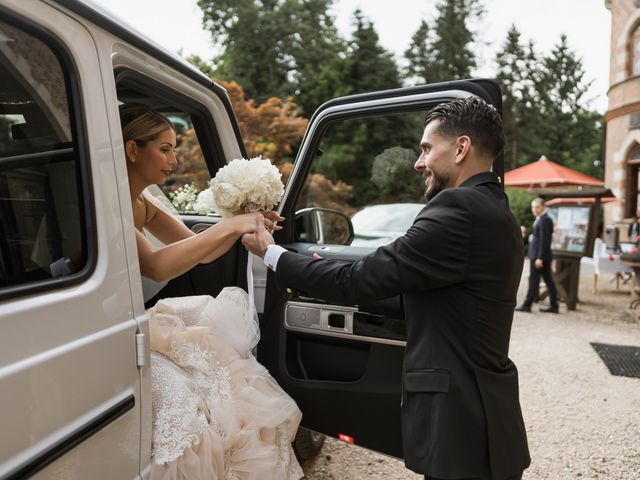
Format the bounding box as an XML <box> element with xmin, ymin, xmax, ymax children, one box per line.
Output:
<box><xmin>258</xmin><ymin>80</ymin><xmax>502</xmax><ymax>457</ymax></box>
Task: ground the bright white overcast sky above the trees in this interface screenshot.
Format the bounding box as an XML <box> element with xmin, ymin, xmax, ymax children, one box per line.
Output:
<box><xmin>93</xmin><ymin>0</ymin><xmax>611</xmax><ymax>113</ymax></box>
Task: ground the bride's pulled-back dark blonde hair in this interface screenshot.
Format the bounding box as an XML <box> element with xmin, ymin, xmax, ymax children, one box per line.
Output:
<box><xmin>120</xmin><ymin>103</ymin><xmax>176</xmax><ymax>147</ymax></box>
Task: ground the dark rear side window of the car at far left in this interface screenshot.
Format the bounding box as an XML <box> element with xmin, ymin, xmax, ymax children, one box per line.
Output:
<box><xmin>0</xmin><ymin>17</ymin><xmax>87</xmax><ymax>289</ymax></box>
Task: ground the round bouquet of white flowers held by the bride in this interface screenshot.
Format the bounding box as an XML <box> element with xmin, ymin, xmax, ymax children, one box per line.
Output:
<box><xmin>210</xmin><ymin>156</ymin><xmax>284</xmax><ymax>217</ymax></box>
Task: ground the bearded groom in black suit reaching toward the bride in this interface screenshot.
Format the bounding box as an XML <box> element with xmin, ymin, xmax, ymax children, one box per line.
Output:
<box><xmin>242</xmin><ymin>97</ymin><xmax>530</xmax><ymax>480</ymax></box>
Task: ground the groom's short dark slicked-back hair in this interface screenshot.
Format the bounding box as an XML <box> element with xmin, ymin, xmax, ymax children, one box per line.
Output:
<box><xmin>424</xmin><ymin>97</ymin><xmax>504</xmax><ymax>158</ymax></box>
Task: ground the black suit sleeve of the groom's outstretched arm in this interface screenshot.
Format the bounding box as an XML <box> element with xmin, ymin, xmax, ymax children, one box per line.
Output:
<box><xmin>275</xmin><ymin>189</ymin><xmax>472</xmax><ymax>304</ymax></box>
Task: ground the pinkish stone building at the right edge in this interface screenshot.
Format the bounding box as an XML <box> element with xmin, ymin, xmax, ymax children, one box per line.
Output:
<box><xmin>604</xmin><ymin>0</ymin><xmax>640</xmax><ymax>235</ymax></box>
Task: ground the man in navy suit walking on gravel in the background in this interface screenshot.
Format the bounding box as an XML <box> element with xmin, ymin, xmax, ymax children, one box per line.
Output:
<box><xmin>516</xmin><ymin>198</ymin><xmax>560</xmax><ymax>313</ymax></box>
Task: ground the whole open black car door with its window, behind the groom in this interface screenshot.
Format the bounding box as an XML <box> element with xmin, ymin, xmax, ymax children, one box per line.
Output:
<box><xmin>258</xmin><ymin>80</ymin><xmax>503</xmax><ymax>458</ymax></box>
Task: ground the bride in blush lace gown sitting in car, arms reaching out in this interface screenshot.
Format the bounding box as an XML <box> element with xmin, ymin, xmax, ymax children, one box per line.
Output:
<box><xmin>120</xmin><ymin>105</ymin><xmax>302</xmax><ymax>480</ymax></box>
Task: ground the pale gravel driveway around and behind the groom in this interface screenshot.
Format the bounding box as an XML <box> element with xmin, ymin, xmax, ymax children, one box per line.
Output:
<box><xmin>303</xmin><ymin>271</ymin><xmax>640</xmax><ymax>480</ymax></box>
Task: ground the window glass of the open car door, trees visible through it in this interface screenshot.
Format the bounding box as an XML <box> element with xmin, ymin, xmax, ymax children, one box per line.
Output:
<box><xmin>296</xmin><ymin>111</ymin><xmax>426</xmax><ymax>247</ymax></box>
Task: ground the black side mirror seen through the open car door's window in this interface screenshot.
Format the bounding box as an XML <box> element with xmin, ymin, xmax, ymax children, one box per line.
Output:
<box><xmin>296</xmin><ymin>207</ymin><xmax>353</xmax><ymax>245</ymax></box>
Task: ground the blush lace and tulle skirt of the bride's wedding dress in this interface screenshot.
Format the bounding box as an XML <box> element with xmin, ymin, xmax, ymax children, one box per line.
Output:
<box><xmin>149</xmin><ymin>288</ymin><xmax>303</xmax><ymax>480</ymax></box>
